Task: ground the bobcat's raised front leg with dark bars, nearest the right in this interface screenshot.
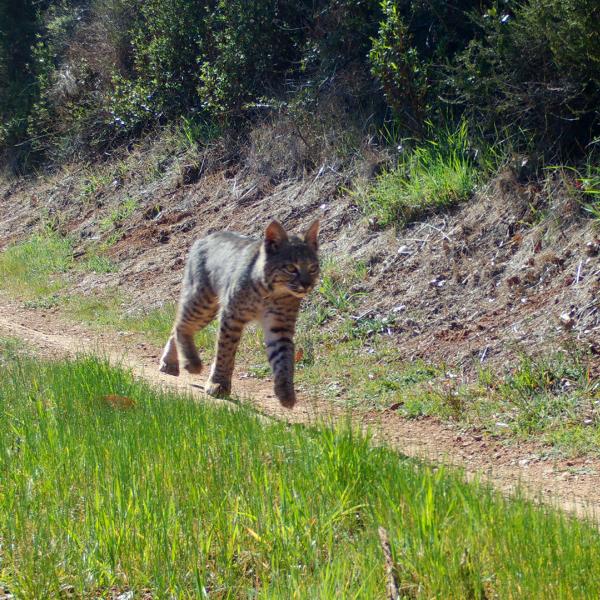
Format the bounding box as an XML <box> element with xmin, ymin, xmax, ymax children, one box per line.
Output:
<box><xmin>262</xmin><ymin>310</ymin><xmax>296</xmax><ymax>408</ymax></box>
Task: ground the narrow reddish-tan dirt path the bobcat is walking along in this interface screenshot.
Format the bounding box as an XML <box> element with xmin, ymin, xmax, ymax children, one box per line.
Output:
<box><xmin>0</xmin><ymin>296</ymin><xmax>600</xmax><ymax>521</ymax></box>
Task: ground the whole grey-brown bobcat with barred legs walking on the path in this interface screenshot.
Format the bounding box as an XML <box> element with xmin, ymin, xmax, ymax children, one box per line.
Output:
<box><xmin>160</xmin><ymin>221</ymin><xmax>319</xmax><ymax>408</ymax></box>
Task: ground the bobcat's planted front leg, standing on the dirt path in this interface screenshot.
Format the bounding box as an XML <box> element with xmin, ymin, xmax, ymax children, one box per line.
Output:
<box><xmin>204</xmin><ymin>311</ymin><xmax>245</xmax><ymax>396</ymax></box>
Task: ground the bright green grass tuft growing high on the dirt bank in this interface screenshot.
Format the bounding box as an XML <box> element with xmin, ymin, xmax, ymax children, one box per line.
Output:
<box><xmin>361</xmin><ymin>122</ymin><xmax>478</xmax><ymax>226</ymax></box>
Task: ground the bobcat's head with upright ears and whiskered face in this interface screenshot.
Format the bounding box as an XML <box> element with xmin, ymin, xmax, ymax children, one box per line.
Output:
<box><xmin>263</xmin><ymin>221</ymin><xmax>319</xmax><ymax>298</ymax></box>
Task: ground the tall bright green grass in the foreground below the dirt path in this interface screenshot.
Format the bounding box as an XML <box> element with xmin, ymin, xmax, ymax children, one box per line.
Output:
<box><xmin>0</xmin><ymin>341</ymin><xmax>600</xmax><ymax>598</ymax></box>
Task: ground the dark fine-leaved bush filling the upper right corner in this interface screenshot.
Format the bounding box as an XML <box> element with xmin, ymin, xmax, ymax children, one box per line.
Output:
<box><xmin>448</xmin><ymin>0</ymin><xmax>600</xmax><ymax>154</ymax></box>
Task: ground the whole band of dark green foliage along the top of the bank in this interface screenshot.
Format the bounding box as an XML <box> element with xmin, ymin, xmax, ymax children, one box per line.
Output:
<box><xmin>0</xmin><ymin>0</ymin><xmax>600</xmax><ymax>169</ymax></box>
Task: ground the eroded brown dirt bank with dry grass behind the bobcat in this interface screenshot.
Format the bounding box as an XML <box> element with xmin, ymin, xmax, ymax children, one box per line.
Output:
<box><xmin>0</xmin><ymin>159</ymin><xmax>600</xmax><ymax>375</ymax></box>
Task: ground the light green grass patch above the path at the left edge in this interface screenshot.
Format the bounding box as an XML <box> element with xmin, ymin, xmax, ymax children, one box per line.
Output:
<box><xmin>0</xmin><ymin>229</ymin><xmax>73</xmax><ymax>299</ymax></box>
